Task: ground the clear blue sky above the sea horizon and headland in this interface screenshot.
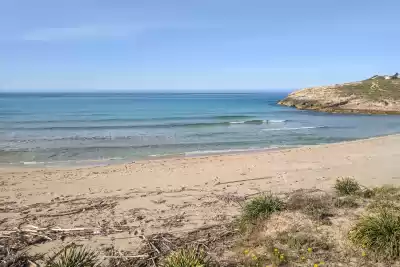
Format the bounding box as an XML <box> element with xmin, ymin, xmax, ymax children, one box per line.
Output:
<box><xmin>0</xmin><ymin>0</ymin><xmax>400</xmax><ymax>91</ymax></box>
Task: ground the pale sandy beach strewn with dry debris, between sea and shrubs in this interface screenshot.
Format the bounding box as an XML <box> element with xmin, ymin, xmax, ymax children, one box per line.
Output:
<box><xmin>0</xmin><ymin>135</ymin><xmax>400</xmax><ymax>256</ymax></box>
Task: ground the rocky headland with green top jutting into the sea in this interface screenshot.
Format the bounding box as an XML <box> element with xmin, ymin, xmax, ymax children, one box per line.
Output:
<box><xmin>278</xmin><ymin>74</ymin><xmax>400</xmax><ymax>114</ymax></box>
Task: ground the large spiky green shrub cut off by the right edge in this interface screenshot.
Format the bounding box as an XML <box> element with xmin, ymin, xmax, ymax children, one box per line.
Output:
<box><xmin>350</xmin><ymin>210</ymin><xmax>400</xmax><ymax>259</ymax></box>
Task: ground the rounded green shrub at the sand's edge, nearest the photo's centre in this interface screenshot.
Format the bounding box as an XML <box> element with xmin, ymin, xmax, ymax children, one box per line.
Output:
<box><xmin>242</xmin><ymin>194</ymin><xmax>284</xmax><ymax>221</ymax></box>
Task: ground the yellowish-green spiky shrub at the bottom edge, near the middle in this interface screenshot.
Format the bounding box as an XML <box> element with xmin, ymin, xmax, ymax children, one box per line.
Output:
<box><xmin>162</xmin><ymin>248</ymin><xmax>210</xmax><ymax>267</ymax></box>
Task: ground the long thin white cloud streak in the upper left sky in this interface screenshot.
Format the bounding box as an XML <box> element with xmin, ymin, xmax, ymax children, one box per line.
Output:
<box><xmin>22</xmin><ymin>25</ymin><xmax>140</xmax><ymax>41</ymax></box>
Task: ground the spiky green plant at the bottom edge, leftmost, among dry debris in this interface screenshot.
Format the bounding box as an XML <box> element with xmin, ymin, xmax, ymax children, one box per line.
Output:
<box><xmin>46</xmin><ymin>245</ymin><xmax>100</xmax><ymax>267</ymax></box>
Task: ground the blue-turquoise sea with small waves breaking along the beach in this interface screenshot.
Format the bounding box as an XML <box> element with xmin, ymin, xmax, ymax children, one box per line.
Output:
<box><xmin>0</xmin><ymin>92</ymin><xmax>400</xmax><ymax>167</ymax></box>
